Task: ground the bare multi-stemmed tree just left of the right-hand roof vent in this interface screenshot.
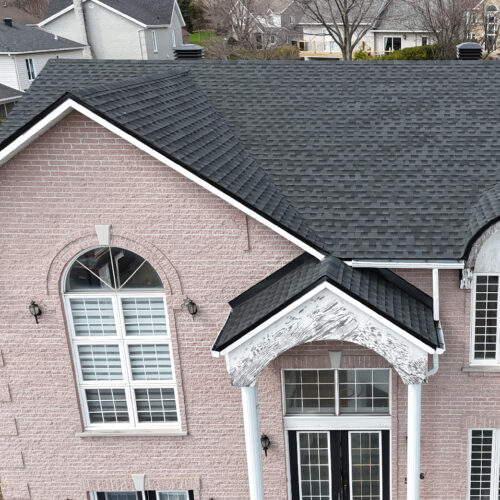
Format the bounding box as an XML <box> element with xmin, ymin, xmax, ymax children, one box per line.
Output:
<box><xmin>407</xmin><ymin>0</ymin><xmax>479</xmax><ymax>59</ymax></box>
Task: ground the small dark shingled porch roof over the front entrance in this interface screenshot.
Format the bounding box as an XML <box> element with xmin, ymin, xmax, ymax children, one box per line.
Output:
<box><xmin>213</xmin><ymin>254</ymin><xmax>442</xmax><ymax>351</ymax></box>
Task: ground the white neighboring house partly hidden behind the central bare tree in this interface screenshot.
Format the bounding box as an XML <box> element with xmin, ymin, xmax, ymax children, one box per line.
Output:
<box><xmin>299</xmin><ymin>0</ymin><xmax>431</xmax><ymax>59</ymax></box>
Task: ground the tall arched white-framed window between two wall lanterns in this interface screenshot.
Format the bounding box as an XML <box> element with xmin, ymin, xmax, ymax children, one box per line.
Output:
<box><xmin>64</xmin><ymin>247</ymin><xmax>180</xmax><ymax>429</ymax></box>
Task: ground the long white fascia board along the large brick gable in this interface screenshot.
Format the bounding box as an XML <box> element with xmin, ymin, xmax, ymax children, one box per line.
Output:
<box><xmin>0</xmin><ymin>99</ymin><xmax>326</xmax><ymax>260</ymax></box>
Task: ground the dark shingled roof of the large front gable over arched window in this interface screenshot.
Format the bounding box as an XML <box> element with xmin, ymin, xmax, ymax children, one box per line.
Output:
<box><xmin>0</xmin><ymin>68</ymin><xmax>320</xmax><ymax>256</ymax></box>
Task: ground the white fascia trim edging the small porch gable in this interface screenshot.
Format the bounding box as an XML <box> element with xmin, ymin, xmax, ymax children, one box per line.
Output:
<box><xmin>212</xmin><ymin>281</ymin><xmax>436</xmax><ymax>357</ymax></box>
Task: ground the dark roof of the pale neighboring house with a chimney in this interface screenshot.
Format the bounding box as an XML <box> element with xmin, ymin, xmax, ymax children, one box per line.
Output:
<box><xmin>44</xmin><ymin>0</ymin><xmax>175</xmax><ymax>25</ymax></box>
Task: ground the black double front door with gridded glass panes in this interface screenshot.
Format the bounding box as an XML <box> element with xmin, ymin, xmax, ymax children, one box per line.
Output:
<box><xmin>288</xmin><ymin>430</ymin><xmax>390</xmax><ymax>500</ymax></box>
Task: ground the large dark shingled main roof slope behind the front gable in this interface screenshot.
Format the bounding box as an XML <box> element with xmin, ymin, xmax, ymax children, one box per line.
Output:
<box><xmin>0</xmin><ymin>60</ymin><xmax>500</xmax><ymax>260</ymax></box>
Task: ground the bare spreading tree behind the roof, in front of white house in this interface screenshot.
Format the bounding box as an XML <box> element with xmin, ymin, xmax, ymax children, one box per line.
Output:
<box><xmin>297</xmin><ymin>0</ymin><xmax>391</xmax><ymax>61</ymax></box>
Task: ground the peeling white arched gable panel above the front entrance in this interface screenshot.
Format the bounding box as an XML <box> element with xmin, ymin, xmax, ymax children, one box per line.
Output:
<box><xmin>224</xmin><ymin>288</ymin><xmax>428</xmax><ymax>387</ymax></box>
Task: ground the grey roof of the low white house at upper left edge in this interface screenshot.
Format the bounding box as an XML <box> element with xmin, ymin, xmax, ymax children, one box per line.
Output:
<box><xmin>0</xmin><ymin>20</ymin><xmax>84</xmax><ymax>53</ymax></box>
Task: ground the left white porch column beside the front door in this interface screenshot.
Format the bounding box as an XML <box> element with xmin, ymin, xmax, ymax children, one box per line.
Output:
<box><xmin>241</xmin><ymin>385</ymin><xmax>264</xmax><ymax>500</ymax></box>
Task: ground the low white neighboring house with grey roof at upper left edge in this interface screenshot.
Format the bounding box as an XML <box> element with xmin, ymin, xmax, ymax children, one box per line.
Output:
<box><xmin>0</xmin><ymin>19</ymin><xmax>84</xmax><ymax>90</ymax></box>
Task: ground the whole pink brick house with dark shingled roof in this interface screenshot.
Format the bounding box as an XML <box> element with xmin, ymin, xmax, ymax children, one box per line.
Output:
<box><xmin>0</xmin><ymin>60</ymin><xmax>500</xmax><ymax>500</ymax></box>
